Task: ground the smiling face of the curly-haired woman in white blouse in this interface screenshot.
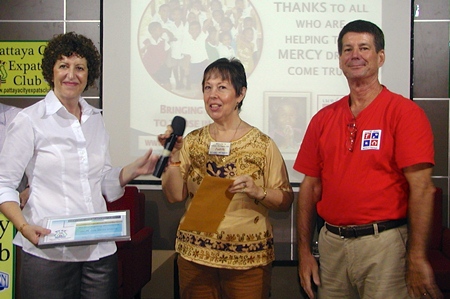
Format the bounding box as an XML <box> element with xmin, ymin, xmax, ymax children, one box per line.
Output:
<box><xmin>53</xmin><ymin>54</ymin><xmax>88</xmax><ymax>102</ymax></box>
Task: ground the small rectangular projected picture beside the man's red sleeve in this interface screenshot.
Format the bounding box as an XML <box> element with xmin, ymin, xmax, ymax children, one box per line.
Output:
<box><xmin>264</xmin><ymin>92</ymin><xmax>311</xmax><ymax>153</ymax></box>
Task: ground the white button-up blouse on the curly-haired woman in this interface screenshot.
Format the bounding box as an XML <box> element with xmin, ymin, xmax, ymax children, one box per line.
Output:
<box><xmin>0</xmin><ymin>91</ymin><xmax>124</xmax><ymax>261</ymax></box>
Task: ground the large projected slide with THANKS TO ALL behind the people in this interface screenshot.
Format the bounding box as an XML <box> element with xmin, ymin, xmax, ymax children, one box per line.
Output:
<box><xmin>102</xmin><ymin>0</ymin><xmax>410</xmax><ymax>182</ymax></box>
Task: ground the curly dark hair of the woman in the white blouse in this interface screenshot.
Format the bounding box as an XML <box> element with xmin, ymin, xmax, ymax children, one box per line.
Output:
<box><xmin>42</xmin><ymin>32</ymin><xmax>101</xmax><ymax>90</ymax></box>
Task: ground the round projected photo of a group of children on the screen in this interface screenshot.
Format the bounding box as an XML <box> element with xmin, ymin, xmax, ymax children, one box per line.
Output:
<box><xmin>137</xmin><ymin>0</ymin><xmax>262</xmax><ymax>99</ymax></box>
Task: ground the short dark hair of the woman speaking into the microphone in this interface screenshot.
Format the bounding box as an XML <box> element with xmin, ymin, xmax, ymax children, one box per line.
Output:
<box><xmin>202</xmin><ymin>58</ymin><xmax>247</xmax><ymax>109</ymax></box>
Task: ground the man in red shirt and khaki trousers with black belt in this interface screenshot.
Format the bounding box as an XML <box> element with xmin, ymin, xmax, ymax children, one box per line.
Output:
<box><xmin>294</xmin><ymin>20</ymin><xmax>442</xmax><ymax>298</ymax></box>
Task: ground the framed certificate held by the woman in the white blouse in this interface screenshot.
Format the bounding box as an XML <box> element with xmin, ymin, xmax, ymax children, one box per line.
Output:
<box><xmin>38</xmin><ymin>210</ymin><xmax>131</xmax><ymax>247</ymax></box>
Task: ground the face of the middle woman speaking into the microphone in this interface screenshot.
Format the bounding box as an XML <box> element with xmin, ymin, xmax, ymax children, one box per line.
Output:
<box><xmin>203</xmin><ymin>72</ymin><xmax>246</xmax><ymax>123</ymax></box>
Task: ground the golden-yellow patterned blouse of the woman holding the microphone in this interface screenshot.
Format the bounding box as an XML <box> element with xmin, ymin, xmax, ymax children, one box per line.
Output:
<box><xmin>175</xmin><ymin>126</ymin><xmax>292</xmax><ymax>269</ymax></box>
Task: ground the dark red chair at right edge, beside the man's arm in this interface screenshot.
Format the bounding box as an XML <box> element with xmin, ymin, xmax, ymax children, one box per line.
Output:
<box><xmin>428</xmin><ymin>188</ymin><xmax>450</xmax><ymax>299</ymax></box>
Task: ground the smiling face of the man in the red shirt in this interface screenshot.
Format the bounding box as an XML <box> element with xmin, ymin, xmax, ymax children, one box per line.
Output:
<box><xmin>339</xmin><ymin>32</ymin><xmax>385</xmax><ymax>80</ymax></box>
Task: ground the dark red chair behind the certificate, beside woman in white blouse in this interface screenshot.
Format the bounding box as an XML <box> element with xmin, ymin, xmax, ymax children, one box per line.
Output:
<box><xmin>107</xmin><ymin>186</ymin><xmax>153</xmax><ymax>299</ymax></box>
